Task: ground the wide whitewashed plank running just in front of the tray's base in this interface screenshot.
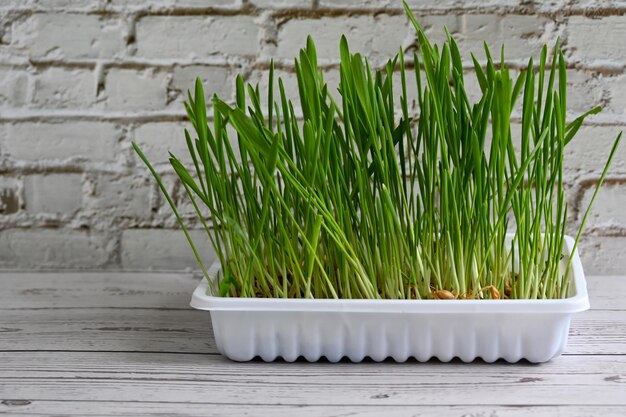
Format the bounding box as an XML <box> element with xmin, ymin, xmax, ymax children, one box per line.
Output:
<box><xmin>0</xmin><ymin>352</ymin><xmax>626</xmax><ymax>406</ymax></box>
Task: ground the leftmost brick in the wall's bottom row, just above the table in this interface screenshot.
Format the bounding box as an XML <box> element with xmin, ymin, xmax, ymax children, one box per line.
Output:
<box><xmin>0</xmin><ymin>229</ymin><xmax>112</xmax><ymax>269</ymax></box>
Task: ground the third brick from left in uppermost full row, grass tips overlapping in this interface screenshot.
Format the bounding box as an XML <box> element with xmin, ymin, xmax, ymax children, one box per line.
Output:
<box><xmin>276</xmin><ymin>16</ymin><xmax>409</xmax><ymax>61</ymax></box>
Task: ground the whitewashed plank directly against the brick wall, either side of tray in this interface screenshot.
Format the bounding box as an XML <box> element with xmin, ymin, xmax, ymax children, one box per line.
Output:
<box><xmin>0</xmin><ymin>272</ymin><xmax>626</xmax><ymax>310</ymax></box>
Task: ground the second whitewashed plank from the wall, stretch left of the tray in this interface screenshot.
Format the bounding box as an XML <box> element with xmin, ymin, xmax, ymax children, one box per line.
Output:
<box><xmin>0</xmin><ymin>308</ymin><xmax>217</xmax><ymax>353</ymax></box>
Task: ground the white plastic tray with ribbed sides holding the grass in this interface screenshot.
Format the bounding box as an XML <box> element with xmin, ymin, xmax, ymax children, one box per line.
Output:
<box><xmin>191</xmin><ymin>236</ymin><xmax>589</xmax><ymax>362</ymax></box>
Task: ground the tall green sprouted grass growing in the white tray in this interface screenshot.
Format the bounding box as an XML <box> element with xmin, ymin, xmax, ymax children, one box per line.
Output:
<box><xmin>133</xmin><ymin>4</ymin><xmax>621</xmax><ymax>299</ymax></box>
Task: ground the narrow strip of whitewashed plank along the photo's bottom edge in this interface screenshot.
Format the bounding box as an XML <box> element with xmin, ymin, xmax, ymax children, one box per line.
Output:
<box><xmin>0</xmin><ymin>400</ymin><xmax>626</xmax><ymax>417</ymax></box>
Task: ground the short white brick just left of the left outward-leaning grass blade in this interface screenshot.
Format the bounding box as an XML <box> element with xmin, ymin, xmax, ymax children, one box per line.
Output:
<box><xmin>84</xmin><ymin>174</ymin><xmax>153</xmax><ymax>219</ymax></box>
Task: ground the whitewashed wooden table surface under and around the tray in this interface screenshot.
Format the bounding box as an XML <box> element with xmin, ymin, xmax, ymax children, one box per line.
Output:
<box><xmin>0</xmin><ymin>272</ymin><xmax>626</xmax><ymax>417</ymax></box>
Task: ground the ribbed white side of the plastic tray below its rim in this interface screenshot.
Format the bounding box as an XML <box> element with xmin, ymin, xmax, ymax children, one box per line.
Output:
<box><xmin>211</xmin><ymin>311</ymin><xmax>570</xmax><ymax>362</ymax></box>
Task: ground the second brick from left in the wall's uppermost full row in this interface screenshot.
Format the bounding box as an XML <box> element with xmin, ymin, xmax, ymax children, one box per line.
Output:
<box><xmin>136</xmin><ymin>16</ymin><xmax>259</xmax><ymax>59</ymax></box>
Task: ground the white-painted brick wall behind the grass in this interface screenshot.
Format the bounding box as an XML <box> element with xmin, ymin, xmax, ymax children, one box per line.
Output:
<box><xmin>0</xmin><ymin>0</ymin><xmax>626</xmax><ymax>274</ymax></box>
